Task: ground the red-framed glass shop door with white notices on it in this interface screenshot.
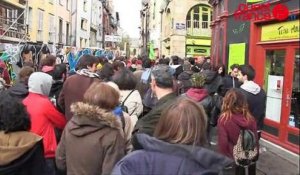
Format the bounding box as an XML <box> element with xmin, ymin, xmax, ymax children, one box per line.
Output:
<box><xmin>263</xmin><ymin>46</ymin><xmax>300</xmax><ymax>153</ymax></box>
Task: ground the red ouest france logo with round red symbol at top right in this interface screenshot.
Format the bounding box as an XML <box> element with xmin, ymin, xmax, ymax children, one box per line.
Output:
<box><xmin>234</xmin><ymin>2</ymin><xmax>289</xmax><ymax>21</ymax></box>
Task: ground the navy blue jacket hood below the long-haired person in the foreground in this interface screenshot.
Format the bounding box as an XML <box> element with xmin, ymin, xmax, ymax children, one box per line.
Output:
<box><xmin>137</xmin><ymin>134</ymin><xmax>233</xmax><ymax>172</ymax></box>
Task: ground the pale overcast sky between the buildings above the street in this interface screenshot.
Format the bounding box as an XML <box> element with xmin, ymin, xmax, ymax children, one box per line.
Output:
<box><xmin>114</xmin><ymin>0</ymin><xmax>141</xmax><ymax>38</ymax></box>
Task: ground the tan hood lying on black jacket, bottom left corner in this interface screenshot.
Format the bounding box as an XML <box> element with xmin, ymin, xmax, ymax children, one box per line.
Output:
<box><xmin>0</xmin><ymin>131</ymin><xmax>42</xmax><ymax>166</ymax></box>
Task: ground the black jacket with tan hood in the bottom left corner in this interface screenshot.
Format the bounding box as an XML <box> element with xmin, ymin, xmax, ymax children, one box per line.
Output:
<box><xmin>0</xmin><ymin>132</ymin><xmax>46</xmax><ymax>175</ymax></box>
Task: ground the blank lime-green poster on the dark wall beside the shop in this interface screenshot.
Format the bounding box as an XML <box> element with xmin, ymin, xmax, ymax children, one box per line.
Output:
<box><xmin>227</xmin><ymin>43</ymin><xmax>246</xmax><ymax>72</ymax></box>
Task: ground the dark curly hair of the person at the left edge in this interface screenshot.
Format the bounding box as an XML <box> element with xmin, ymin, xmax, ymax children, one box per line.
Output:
<box><xmin>0</xmin><ymin>92</ymin><xmax>31</xmax><ymax>133</ymax></box>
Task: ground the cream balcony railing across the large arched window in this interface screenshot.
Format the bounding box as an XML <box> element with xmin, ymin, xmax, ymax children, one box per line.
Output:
<box><xmin>186</xmin><ymin>20</ymin><xmax>211</xmax><ymax>37</ymax></box>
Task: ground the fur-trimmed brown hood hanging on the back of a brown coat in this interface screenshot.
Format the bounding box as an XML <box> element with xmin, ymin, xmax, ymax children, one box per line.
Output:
<box><xmin>69</xmin><ymin>102</ymin><xmax>122</xmax><ymax>137</ymax></box>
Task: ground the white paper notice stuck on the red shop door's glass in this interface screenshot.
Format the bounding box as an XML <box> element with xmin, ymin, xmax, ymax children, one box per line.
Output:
<box><xmin>266</xmin><ymin>75</ymin><xmax>283</xmax><ymax>123</ymax></box>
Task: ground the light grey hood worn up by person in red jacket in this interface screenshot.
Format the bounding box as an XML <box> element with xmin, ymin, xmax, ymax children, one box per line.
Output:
<box><xmin>28</xmin><ymin>72</ymin><xmax>52</xmax><ymax>96</ymax></box>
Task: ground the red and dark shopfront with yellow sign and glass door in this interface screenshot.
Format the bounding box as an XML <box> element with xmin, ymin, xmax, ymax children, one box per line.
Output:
<box><xmin>210</xmin><ymin>0</ymin><xmax>300</xmax><ymax>154</ymax></box>
